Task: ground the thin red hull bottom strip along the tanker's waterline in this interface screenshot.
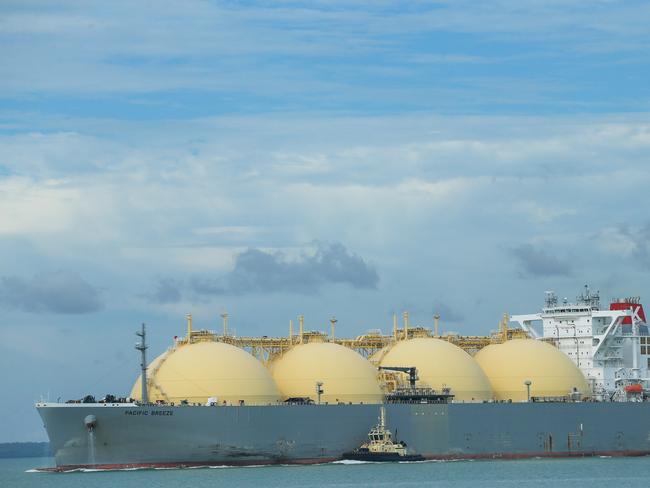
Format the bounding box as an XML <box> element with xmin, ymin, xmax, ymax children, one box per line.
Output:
<box><xmin>31</xmin><ymin>450</ymin><xmax>650</xmax><ymax>473</ymax></box>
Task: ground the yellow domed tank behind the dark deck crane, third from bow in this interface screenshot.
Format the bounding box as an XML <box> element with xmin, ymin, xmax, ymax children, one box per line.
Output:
<box><xmin>381</xmin><ymin>338</ymin><xmax>492</xmax><ymax>401</ymax></box>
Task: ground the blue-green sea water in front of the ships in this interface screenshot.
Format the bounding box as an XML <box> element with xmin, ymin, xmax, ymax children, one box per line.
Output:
<box><xmin>0</xmin><ymin>457</ymin><xmax>650</xmax><ymax>488</ymax></box>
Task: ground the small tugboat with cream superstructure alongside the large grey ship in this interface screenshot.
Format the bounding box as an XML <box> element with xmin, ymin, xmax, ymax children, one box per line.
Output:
<box><xmin>342</xmin><ymin>405</ymin><xmax>424</xmax><ymax>462</ymax></box>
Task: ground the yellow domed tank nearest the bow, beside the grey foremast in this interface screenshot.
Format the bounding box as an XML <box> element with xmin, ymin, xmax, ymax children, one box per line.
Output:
<box><xmin>131</xmin><ymin>342</ymin><xmax>280</xmax><ymax>405</ymax></box>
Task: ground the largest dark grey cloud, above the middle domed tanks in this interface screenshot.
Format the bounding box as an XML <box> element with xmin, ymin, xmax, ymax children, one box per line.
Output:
<box><xmin>190</xmin><ymin>242</ymin><xmax>379</xmax><ymax>295</ymax></box>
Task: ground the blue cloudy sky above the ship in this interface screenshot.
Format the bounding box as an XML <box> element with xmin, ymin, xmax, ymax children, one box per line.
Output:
<box><xmin>0</xmin><ymin>0</ymin><xmax>650</xmax><ymax>442</ymax></box>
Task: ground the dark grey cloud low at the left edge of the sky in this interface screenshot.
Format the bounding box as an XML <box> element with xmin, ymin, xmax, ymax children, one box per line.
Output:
<box><xmin>0</xmin><ymin>271</ymin><xmax>103</xmax><ymax>314</ymax></box>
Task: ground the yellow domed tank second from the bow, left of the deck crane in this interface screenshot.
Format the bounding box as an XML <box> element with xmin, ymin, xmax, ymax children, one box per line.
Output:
<box><xmin>271</xmin><ymin>342</ymin><xmax>383</xmax><ymax>403</ymax></box>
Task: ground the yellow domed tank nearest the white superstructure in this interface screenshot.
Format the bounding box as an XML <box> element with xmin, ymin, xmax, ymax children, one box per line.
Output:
<box><xmin>475</xmin><ymin>339</ymin><xmax>590</xmax><ymax>401</ymax></box>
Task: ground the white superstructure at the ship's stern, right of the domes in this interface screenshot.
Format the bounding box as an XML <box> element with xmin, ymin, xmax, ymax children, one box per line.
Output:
<box><xmin>511</xmin><ymin>286</ymin><xmax>650</xmax><ymax>400</ymax></box>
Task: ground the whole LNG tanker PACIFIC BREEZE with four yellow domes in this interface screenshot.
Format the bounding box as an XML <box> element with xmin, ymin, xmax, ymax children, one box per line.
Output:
<box><xmin>36</xmin><ymin>290</ymin><xmax>650</xmax><ymax>471</ymax></box>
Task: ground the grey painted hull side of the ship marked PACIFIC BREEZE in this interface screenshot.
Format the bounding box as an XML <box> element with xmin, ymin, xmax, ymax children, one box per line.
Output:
<box><xmin>37</xmin><ymin>403</ymin><xmax>650</xmax><ymax>467</ymax></box>
